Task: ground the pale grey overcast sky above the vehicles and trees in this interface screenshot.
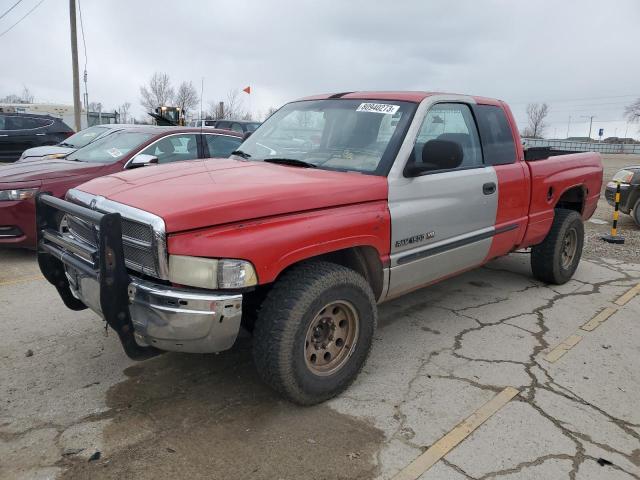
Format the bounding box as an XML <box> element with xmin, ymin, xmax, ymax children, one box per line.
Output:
<box><xmin>0</xmin><ymin>0</ymin><xmax>640</xmax><ymax>137</ymax></box>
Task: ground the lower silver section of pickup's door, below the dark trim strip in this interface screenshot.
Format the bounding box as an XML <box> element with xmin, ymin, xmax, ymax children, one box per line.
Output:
<box><xmin>387</xmin><ymin>237</ymin><xmax>491</xmax><ymax>297</ymax></box>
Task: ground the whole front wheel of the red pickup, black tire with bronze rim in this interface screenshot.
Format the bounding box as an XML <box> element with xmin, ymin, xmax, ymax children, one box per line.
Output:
<box><xmin>253</xmin><ymin>261</ymin><xmax>378</xmax><ymax>405</ymax></box>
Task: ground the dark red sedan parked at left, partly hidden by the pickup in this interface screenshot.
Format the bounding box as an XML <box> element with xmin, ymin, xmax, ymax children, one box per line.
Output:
<box><xmin>0</xmin><ymin>126</ymin><xmax>243</xmax><ymax>248</ymax></box>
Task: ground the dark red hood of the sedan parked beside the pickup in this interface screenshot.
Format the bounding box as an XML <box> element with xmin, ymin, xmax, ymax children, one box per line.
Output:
<box><xmin>0</xmin><ymin>159</ymin><xmax>106</xmax><ymax>183</ymax></box>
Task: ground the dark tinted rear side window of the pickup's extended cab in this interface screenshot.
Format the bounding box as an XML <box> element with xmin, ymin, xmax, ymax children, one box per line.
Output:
<box><xmin>475</xmin><ymin>105</ymin><xmax>516</xmax><ymax>165</ymax></box>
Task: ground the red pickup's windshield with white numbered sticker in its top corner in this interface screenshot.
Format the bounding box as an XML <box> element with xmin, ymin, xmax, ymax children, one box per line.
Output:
<box><xmin>236</xmin><ymin>99</ymin><xmax>417</xmax><ymax>175</ymax></box>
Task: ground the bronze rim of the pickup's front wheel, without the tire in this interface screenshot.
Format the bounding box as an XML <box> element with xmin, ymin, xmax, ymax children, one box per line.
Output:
<box><xmin>304</xmin><ymin>301</ymin><xmax>360</xmax><ymax>376</ymax></box>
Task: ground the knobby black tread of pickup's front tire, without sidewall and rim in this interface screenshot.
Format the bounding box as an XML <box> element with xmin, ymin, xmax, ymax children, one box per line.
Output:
<box><xmin>253</xmin><ymin>261</ymin><xmax>377</xmax><ymax>405</ymax></box>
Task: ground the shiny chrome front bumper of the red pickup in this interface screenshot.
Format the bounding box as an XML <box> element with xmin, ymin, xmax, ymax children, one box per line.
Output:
<box><xmin>65</xmin><ymin>272</ymin><xmax>242</xmax><ymax>353</ymax></box>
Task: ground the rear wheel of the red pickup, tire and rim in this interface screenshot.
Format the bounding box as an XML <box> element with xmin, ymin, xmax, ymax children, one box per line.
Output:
<box><xmin>531</xmin><ymin>208</ymin><xmax>584</xmax><ymax>285</ymax></box>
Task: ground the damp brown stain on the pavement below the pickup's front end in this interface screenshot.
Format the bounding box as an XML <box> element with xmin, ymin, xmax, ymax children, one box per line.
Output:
<box><xmin>62</xmin><ymin>338</ymin><xmax>384</xmax><ymax>479</ymax></box>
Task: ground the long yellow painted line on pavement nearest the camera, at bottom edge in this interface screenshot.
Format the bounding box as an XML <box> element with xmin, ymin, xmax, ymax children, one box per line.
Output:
<box><xmin>393</xmin><ymin>387</ymin><xmax>520</xmax><ymax>480</ymax></box>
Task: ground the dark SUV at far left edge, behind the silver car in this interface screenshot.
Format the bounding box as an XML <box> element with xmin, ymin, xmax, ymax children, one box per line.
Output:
<box><xmin>0</xmin><ymin>113</ymin><xmax>74</xmax><ymax>162</ymax></box>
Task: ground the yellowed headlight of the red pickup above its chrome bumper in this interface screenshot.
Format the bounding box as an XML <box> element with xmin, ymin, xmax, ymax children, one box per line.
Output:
<box><xmin>169</xmin><ymin>255</ymin><xmax>258</xmax><ymax>290</ymax></box>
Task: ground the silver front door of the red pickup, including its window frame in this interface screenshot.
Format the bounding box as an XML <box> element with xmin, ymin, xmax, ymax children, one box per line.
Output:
<box><xmin>386</xmin><ymin>95</ymin><xmax>498</xmax><ymax>298</ymax></box>
